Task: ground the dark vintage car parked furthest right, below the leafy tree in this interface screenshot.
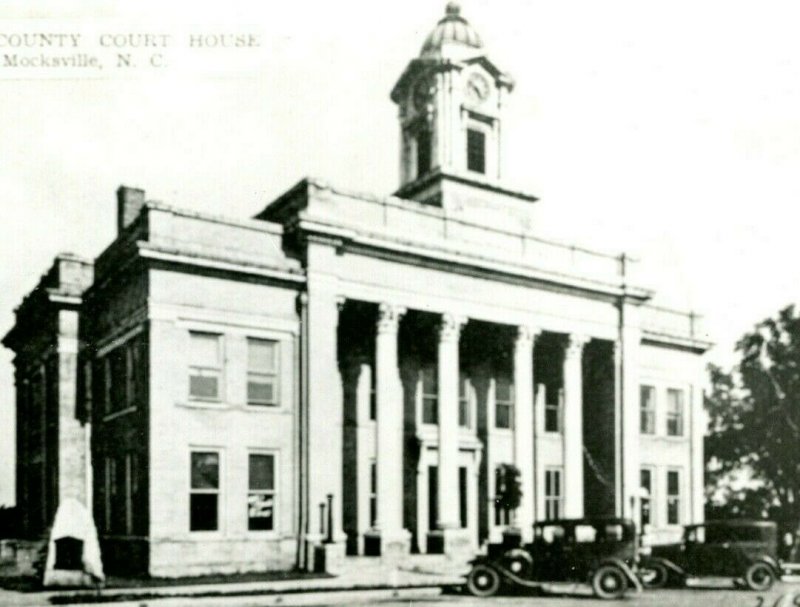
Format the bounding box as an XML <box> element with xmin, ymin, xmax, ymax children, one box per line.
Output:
<box><xmin>638</xmin><ymin>520</ymin><xmax>781</xmax><ymax>592</ymax></box>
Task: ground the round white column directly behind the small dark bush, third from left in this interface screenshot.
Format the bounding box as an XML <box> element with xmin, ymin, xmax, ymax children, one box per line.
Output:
<box><xmin>514</xmin><ymin>326</ymin><xmax>538</xmax><ymax>542</ymax></box>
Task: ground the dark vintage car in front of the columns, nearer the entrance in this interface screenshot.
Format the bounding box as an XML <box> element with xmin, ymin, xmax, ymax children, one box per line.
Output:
<box><xmin>467</xmin><ymin>518</ymin><xmax>641</xmax><ymax>599</ymax></box>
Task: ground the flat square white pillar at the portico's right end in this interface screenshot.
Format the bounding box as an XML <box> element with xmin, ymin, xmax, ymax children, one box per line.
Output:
<box><xmin>619</xmin><ymin>303</ymin><xmax>641</xmax><ymax>520</ymax></box>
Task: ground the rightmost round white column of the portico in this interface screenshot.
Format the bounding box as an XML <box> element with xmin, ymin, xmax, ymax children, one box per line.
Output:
<box><xmin>564</xmin><ymin>335</ymin><xmax>589</xmax><ymax>518</ymax></box>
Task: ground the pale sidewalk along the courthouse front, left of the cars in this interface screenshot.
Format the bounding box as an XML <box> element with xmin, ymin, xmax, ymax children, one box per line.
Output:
<box><xmin>0</xmin><ymin>559</ymin><xmax>463</xmax><ymax>607</ymax></box>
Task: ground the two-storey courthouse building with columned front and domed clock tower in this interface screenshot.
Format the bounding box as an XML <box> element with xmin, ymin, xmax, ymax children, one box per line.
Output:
<box><xmin>4</xmin><ymin>3</ymin><xmax>709</xmax><ymax>576</ymax></box>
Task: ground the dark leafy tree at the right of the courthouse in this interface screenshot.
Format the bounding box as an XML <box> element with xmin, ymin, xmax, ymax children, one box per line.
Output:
<box><xmin>706</xmin><ymin>306</ymin><xmax>800</xmax><ymax>526</ymax></box>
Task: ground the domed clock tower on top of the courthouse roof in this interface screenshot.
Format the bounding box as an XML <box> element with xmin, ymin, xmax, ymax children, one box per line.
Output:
<box><xmin>391</xmin><ymin>2</ymin><xmax>535</xmax><ymax>208</ymax></box>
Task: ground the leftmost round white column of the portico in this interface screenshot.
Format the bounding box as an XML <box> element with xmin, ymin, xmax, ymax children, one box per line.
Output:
<box><xmin>375</xmin><ymin>304</ymin><xmax>409</xmax><ymax>554</ymax></box>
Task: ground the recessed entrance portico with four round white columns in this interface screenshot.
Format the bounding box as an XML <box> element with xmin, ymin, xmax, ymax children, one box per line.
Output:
<box><xmin>316</xmin><ymin>280</ymin><xmax>622</xmax><ymax>556</ymax></box>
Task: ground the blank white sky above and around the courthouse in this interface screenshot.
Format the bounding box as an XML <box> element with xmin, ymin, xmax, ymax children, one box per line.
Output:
<box><xmin>0</xmin><ymin>0</ymin><xmax>800</xmax><ymax>504</ymax></box>
